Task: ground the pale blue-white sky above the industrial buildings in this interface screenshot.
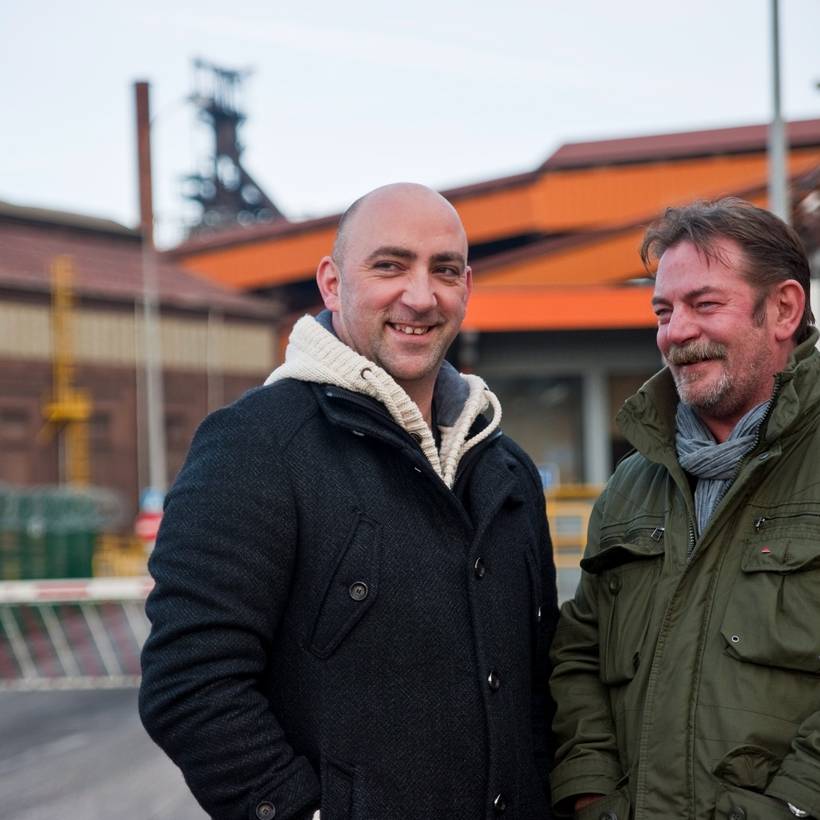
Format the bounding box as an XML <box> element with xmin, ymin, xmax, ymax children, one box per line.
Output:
<box><xmin>0</xmin><ymin>0</ymin><xmax>820</xmax><ymax>246</ymax></box>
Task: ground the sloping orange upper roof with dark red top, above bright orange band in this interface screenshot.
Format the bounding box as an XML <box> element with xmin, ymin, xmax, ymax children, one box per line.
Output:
<box><xmin>169</xmin><ymin>119</ymin><xmax>820</xmax><ymax>308</ymax></box>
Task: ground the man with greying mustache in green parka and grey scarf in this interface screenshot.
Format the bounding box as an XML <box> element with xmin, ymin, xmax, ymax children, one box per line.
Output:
<box><xmin>552</xmin><ymin>199</ymin><xmax>820</xmax><ymax>820</ymax></box>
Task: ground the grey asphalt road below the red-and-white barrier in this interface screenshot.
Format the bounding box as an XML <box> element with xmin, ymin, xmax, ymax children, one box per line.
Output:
<box><xmin>0</xmin><ymin>689</ymin><xmax>207</xmax><ymax>820</ymax></box>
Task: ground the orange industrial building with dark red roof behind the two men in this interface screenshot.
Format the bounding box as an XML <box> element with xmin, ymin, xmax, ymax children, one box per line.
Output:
<box><xmin>168</xmin><ymin>120</ymin><xmax>820</xmax><ymax>484</ymax></box>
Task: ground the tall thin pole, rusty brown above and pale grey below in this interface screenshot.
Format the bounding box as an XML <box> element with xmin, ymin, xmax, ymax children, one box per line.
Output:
<box><xmin>134</xmin><ymin>82</ymin><xmax>167</xmax><ymax>494</ymax></box>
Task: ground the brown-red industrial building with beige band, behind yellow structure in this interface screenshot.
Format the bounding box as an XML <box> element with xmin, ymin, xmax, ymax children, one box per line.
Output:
<box><xmin>0</xmin><ymin>203</ymin><xmax>277</xmax><ymax>531</ymax></box>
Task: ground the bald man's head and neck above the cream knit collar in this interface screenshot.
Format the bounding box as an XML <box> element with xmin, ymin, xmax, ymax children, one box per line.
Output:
<box><xmin>316</xmin><ymin>182</ymin><xmax>473</xmax><ymax>424</ymax></box>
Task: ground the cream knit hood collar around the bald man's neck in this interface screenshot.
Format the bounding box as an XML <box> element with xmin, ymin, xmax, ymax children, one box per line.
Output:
<box><xmin>265</xmin><ymin>311</ymin><xmax>501</xmax><ymax>489</ymax></box>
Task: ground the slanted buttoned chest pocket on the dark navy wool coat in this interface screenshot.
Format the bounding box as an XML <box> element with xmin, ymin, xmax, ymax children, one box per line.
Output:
<box><xmin>307</xmin><ymin>513</ymin><xmax>381</xmax><ymax>658</ymax></box>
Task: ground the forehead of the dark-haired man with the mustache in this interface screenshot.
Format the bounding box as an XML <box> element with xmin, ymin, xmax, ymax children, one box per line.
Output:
<box><xmin>655</xmin><ymin>239</ymin><xmax>752</xmax><ymax>299</ymax></box>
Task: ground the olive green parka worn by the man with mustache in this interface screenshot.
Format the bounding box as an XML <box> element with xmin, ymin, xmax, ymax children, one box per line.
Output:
<box><xmin>552</xmin><ymin>330</ymin><xmax>820</xmax><ymax>820</ymax></box>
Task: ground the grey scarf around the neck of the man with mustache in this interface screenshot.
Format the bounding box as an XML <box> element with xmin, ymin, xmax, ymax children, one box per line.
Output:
<box><xmin>675</xmin><ymin>402</ymin><xmax>769</xmax><ymax>534</ymax></box>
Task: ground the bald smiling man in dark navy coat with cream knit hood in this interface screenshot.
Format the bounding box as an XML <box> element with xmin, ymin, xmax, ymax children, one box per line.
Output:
<box><xmin>140</xmin><ymin>183</ymin><xmax>557</xmax><ymax>820</ymax></box>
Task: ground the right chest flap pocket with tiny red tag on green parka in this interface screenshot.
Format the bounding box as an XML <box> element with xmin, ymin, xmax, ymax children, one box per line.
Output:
<box><xmin>721</xmin><ymin>530</ymin><xmax>820</xmax><ymax>675</ymax></box>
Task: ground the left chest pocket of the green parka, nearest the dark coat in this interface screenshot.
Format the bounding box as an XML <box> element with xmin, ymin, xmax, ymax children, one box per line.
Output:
<box><xmin>581</xmin><ymin>522</ymin><xmax>665</xmax><ymax>685</ymax></box>
